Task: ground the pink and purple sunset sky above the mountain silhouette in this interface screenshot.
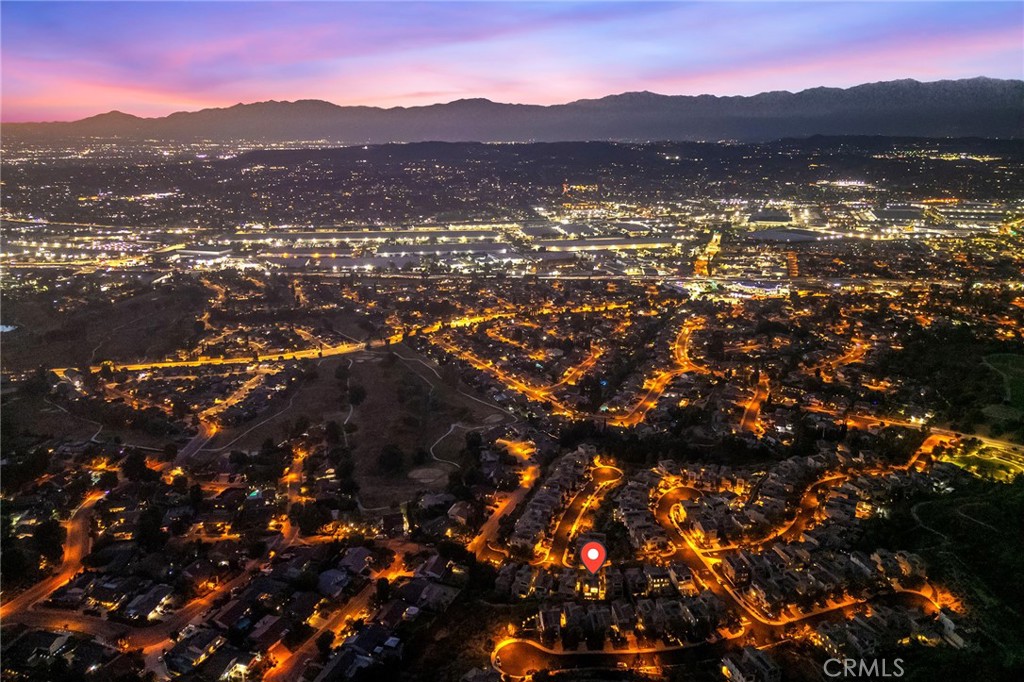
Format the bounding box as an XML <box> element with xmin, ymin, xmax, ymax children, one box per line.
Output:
<box><xmin>0</xmin><ymin>0</ymin><xmax>1024</xmax><ymax>121</ymax></box>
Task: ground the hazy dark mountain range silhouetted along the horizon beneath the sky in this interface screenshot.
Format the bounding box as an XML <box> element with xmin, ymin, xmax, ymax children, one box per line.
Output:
<box><xmin>3</xmin><ymin>77</ymin><xmax>1024</xmax><ymax>143</ymax></box>
